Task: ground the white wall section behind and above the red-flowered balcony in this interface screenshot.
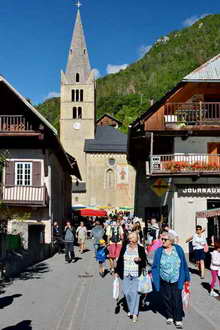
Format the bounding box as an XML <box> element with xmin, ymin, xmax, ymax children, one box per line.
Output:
<box><xmin>174</xmin><ymin>136</ymin><xmax>220</xmax><ymax>154</ymax></box>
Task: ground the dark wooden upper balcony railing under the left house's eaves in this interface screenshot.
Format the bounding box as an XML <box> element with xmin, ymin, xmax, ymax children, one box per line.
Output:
<box><xmin>0</xmin><ymin>115</ymin><xmax>33</xmax><ymax>132</ymax></box>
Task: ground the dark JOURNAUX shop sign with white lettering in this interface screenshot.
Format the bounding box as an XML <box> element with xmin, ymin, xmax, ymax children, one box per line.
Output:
<box><xmin>177</xmin><ymin>185</ymin><xmax>220</xmax><ymax>197</ymax></box>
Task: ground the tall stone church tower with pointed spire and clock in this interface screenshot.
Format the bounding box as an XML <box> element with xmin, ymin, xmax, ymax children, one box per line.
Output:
<box><xmin>60</xmin><ymin>2</ymin><xmax>95</xmax><ymax>203</ymax></box>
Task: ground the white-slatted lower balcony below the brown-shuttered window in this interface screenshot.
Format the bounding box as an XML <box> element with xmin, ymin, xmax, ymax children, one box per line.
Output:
<box><xmin>2</xmin><ymin>185</ymin><xmax>48</xmax><ymax>207</ymax></box>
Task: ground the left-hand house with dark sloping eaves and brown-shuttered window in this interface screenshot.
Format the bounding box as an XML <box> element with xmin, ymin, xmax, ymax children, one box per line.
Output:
<box><xmin>0</xmin><ymin>76</ymin><xmax>80</xmax><ymax>261</ymax></box>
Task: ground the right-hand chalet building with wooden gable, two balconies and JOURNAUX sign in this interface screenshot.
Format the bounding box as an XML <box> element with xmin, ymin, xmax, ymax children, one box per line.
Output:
<box><xmin>128</xmin><ymin>56</ymin><xmax>220</xmax><ymax>249</ymax></box>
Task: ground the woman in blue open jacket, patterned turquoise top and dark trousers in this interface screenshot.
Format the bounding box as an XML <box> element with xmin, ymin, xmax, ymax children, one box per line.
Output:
<box><xmin>152</xmin><ymin>232</ymin><xmax>190</xmax><ymax>329</ymax></box>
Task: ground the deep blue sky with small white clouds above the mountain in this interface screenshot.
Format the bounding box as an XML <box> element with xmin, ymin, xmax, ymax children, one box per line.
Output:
<box><xmin>0</xmin><ymin>0</ymin><xmax>220</xmax><ymax>105</ymax></box>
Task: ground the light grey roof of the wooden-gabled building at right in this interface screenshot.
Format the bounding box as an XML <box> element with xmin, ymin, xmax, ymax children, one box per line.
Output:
<box><xmin>183</xmin><ymin>54</ymin><xmax>220</xmax><ymax>82</ymax></box>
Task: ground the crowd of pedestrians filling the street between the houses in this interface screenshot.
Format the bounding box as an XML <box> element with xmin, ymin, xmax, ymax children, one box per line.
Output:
<box><xmin>54</xmin><ymin>214</ymin><xmax>220</xmax><ymax>329</ymax></box>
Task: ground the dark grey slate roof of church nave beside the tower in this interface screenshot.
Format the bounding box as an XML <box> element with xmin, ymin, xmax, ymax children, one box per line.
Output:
<box><xmin>84</xmin><ymin>126</ymin><xmax>127</xmax><ymax>153</ymax></box>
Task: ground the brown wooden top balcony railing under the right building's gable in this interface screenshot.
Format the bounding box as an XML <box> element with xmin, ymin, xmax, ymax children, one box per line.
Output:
<box><xmin>164</xmin><ymin>102</ymin><xmax>220</xmax><ymax>127</ymax></box>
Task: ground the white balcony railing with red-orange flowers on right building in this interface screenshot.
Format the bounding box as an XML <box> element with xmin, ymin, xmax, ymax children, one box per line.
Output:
<box><xmin>150</xmin><ymin>153</ymin><xmax>220</xmax><ymax>175</ymax></box>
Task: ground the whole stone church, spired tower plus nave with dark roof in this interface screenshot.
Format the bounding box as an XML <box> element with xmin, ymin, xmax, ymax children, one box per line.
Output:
<box><xmin>60</xmin><ymin>9</ymin><xmax>135</xmax><ymax>208</ymax></box>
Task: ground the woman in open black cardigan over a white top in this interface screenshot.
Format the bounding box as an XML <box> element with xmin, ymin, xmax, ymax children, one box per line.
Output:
<box><xmin>115</xmin><ymin>232</ymin><xmax>146</xmax><ymax>322</ymax></box>
